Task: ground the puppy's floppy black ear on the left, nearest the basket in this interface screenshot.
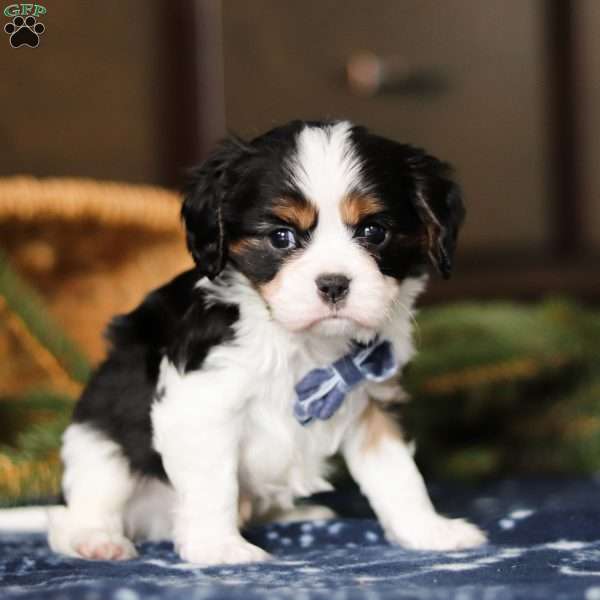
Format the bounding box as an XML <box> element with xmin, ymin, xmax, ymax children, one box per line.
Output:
<box><xmin>181</xmin><ymin>138</ymin><xmax>250</xmax><ymax>279</ymax></box>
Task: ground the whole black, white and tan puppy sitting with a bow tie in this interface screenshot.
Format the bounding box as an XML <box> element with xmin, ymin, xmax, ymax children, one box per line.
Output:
<box><xmin>49</xmin><ymin>121</ymin><xmax>485</xmax><ymax>565</ymax></box>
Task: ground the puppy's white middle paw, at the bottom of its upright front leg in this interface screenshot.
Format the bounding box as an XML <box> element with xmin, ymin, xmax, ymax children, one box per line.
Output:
<box><xmin>177</xmin><ymin>536</ymin><xmax>270</xmax><ymax>567</ymax></box>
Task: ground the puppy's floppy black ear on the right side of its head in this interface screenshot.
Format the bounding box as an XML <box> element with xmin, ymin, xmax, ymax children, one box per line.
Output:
<box><xmin>413</xmin><ymin>163</ymin><xmax>465</xmax><ymax>279</ymax></box>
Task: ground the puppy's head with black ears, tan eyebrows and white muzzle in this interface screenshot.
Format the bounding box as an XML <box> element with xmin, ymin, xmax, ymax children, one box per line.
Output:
<box><xmin>182</xmin><ymin>121</ymin><xmax>464</xmax><ymax>336</ymax></box>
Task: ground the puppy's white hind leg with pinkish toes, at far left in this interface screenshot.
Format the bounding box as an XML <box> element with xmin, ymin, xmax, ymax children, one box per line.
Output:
<box><xmin>48</xmin><ymin>423</ymin><xmax>136</xmax><ymax>560</ymax></box>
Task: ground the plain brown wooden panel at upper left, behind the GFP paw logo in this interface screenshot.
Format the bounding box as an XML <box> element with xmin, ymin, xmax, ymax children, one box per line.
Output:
<box><xmin>0</xmin><ymin>0</ymin><xmax>169</xmax><ymax>183</ymax></box>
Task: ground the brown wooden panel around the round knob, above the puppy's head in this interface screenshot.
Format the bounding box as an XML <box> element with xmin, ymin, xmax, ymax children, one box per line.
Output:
<box><xmin>223</xmin><ymin>0</ymin><xmax>552</xmax><ymax>257</ymax></box>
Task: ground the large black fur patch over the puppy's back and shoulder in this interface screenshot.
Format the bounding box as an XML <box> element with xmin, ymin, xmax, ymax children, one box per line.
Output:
<box><xmin>73</xmin><ymin>270</ymin><xmax>238</xmax><ymax>480</ymax></box>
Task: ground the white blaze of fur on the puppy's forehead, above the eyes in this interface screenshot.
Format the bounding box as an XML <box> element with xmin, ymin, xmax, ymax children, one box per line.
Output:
<box><xmin>290</xmin><ymin>121</ymin><xmax>363</xmax><ymax>213</ymax></box>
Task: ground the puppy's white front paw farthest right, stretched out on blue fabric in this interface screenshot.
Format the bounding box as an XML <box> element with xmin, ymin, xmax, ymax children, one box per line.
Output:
<box><xmin>386</xmin><ymin>513</ymin><xmax>487</xmax><ymax>550</ymax></box>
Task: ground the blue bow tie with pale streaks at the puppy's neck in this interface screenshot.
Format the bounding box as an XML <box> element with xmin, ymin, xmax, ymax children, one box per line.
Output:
<box><xmin>294</xmin><ymin>339</ymin><xmax>398</xmax><ymax>425</ymax></box>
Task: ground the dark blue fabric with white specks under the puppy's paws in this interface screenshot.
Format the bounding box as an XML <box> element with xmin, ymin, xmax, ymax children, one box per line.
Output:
<box><xmin>0</xmin><ymin>480</ymin><xmax>600</xmax><ymax>600</ymax></box>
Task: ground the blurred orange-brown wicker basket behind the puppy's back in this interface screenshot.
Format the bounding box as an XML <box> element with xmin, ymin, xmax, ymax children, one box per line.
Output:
<box><xmin>0</xmin><ymin>177</ymin><xmax>191</xmax><ymax>396</ymax></box>
